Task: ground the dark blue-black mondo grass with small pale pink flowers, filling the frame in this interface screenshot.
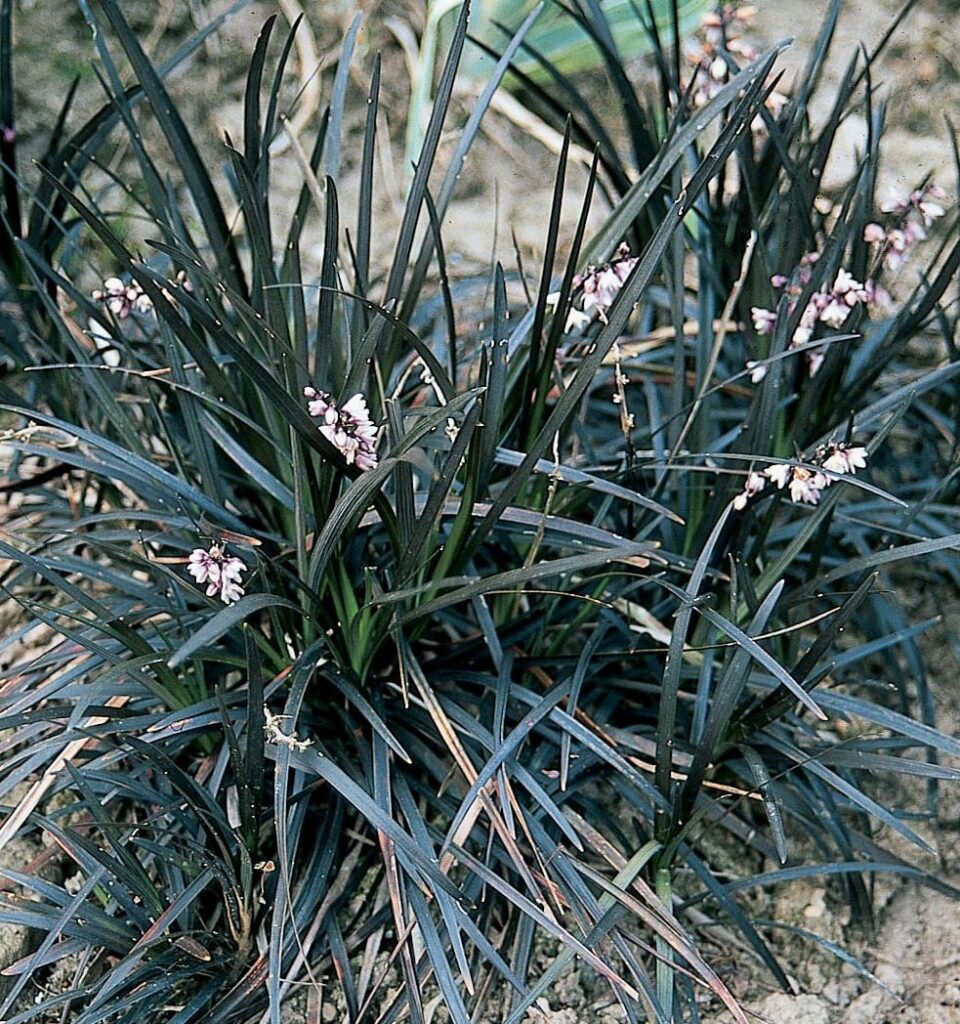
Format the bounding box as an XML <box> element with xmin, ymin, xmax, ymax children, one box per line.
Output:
<box><xmin>0</xmin><ymin>0</ymin><xmax>960</xmax><ymax>1024</ymax></box>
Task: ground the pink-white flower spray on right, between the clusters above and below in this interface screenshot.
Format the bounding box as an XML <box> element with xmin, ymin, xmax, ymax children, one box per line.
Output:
<box><xmin>747</xmin><ymin>252</ymin><xmax>888</xmax><ymax>383</ymax></box>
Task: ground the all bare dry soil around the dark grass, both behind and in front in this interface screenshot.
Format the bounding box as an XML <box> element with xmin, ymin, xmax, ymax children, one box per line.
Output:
<box><xmin>0</xmin><ymin>0</ymin><xmax>960</xmax><ymax>1024</ymax></box>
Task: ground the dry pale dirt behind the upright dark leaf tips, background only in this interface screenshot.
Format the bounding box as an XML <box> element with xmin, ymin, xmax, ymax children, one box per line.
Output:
<box><xmin>7</xmin><ymin>0</ymin><xmax>960</xmax><ymax>282</ymax></box>
